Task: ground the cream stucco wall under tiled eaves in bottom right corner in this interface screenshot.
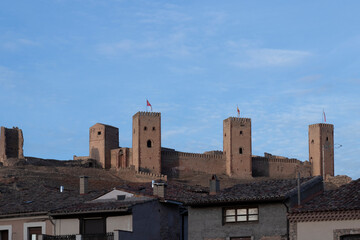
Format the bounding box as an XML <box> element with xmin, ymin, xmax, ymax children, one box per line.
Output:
<box><xmin>292</xmin><ymin>220</ymin><xmax>360</xmax><ymax>240</ymax></box>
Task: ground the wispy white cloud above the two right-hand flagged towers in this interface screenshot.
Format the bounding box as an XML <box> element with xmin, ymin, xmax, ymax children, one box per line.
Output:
<box><xmin>236</xmin><ymin>48</ymin><xmax>312</xmax><ymax>68</ymax></box>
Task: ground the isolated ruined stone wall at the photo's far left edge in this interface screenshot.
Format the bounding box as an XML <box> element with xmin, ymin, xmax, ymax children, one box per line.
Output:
<box><xmin>0</xmin><ymin>127</ymin><xmax>24</xmax><ymax>162</ymax></box>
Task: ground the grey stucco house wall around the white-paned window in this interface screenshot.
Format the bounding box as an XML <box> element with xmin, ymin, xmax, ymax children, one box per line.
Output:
<box><xmin>188</xmin><ymin>203</ymin><xmax>287</xmax><ymax>240</ymax></box>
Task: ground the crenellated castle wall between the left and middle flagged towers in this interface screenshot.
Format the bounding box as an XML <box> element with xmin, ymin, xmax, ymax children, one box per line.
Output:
<box><xmin>161</xmin><ymin>151</ymin><xmax>226</xmax><ymax>177</ymax></box>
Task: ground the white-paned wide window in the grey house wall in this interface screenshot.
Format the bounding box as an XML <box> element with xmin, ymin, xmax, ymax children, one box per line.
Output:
<box><xmin>223</xmin><ymin>207</ymin><xmax>259</xmax><ymax>223</ymax></box>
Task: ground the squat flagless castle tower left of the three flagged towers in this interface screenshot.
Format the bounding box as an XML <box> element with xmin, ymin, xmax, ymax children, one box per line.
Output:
<box><xmin>89</xmin><ymin>123</ymin><xmax>119</xmax><ymax>169</ymax></box>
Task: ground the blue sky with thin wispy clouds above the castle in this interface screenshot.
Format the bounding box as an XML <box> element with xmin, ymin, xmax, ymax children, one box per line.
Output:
<box><xmin>0</xmin><ymin>0</ymin><xmax>360</xmax><ymax>178</ymax></box>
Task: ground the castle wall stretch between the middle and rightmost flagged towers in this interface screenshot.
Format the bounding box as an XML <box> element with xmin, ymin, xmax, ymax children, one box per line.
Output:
<box><xmin>252</xmin><ymin>156</ymin><xmax>311</xmax><ymax>178</ymax></box>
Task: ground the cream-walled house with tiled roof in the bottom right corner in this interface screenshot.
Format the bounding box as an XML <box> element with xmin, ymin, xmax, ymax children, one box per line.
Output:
<box><xmin>288</xmin><ymin>179</ymin><xmax>360</xmax><ymax>240</ymax></box>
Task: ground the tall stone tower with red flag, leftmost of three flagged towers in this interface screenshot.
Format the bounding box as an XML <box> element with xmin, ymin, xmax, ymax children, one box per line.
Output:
<box><xmin>132</xmin><ymin>112</ymin><xmax>161</xmax><ymax>174</ymax></box>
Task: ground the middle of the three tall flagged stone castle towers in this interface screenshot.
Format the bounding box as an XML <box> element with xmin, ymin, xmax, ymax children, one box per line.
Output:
<box><xmin>223</xmin><ymin>117</ymin><xmax>252</xmax><ymax>178</ymax></box>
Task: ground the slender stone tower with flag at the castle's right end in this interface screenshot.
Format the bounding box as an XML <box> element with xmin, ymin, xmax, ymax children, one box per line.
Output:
<box><xmin>309</xmin><ymin>123</ymin><xmax>334</xmax><ymax>177</ymax></box>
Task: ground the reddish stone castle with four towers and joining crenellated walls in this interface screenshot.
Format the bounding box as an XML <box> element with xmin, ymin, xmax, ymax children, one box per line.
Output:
<box><xmin>70</xmin><ymin>112</ymin><xmax>334</xmax><ymax>179</ymax></box>
